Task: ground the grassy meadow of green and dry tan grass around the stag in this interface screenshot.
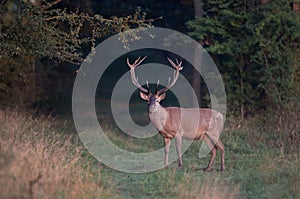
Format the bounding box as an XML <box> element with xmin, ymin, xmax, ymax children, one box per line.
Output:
<box><xmin>0</xmin><ymin>111</ymin><xmax>300</xmax><ymax>199</ymax></box>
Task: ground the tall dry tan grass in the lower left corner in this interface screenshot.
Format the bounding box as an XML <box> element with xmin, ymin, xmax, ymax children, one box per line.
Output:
<box><xmin>0</xmin><ymin>111</ymin><xmax>110</xmax><ymax>199</ymax></box>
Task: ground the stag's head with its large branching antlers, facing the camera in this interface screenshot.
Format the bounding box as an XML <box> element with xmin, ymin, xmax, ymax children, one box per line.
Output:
<box><xmin>127</xmin><ymin>56</ymin><xmax>183</xmax><ymax>113</ymax></box>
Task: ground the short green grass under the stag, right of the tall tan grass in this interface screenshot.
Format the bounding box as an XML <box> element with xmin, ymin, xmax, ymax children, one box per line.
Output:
<box><xmin>82</xmin><ymin>126</ymin><xmax>300</xmax><ymax>198</ymax></box>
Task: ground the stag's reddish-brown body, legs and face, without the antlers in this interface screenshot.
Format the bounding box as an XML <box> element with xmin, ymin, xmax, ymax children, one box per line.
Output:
<box><xmin>141</xmin><ymin>93</ymin><xmax>225</xmax><ymax>171</ymax></box>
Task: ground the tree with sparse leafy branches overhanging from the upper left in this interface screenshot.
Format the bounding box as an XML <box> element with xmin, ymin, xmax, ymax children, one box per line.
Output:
<box><xmin>0</xmin><ymin>0</ymin><xmax>152</xmax><ymax>107</ymax></box>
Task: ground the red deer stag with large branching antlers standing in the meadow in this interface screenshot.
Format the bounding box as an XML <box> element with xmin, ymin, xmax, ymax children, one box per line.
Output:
<box><xmin>127</xmin><ymin>56</ymin><xmax>225</xmax><ymax>171</ymax></box>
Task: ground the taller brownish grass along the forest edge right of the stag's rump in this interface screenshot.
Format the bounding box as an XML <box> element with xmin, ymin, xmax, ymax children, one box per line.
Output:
<box><xmin>226</xmin><ymin>111</ymin><xmax>300</xmax><ymax>159</ymax></box>
